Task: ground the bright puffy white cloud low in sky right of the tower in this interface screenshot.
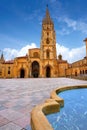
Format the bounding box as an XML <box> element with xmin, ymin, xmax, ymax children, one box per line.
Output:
<box><xmin>57</xmin><ymin>43</ymin><xmax>86</xmax><ymax>63</ymax></box>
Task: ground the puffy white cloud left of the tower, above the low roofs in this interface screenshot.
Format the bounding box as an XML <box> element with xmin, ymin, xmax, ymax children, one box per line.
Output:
<box><xmin>3</xmin><ymin>43</ymin><xmax>36</xmax><ymax>60</ymax></box>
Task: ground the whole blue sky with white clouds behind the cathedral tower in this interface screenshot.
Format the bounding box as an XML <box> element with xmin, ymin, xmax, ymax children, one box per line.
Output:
<box><xmin>0</xmin><ymin>0</ymin><xmax>87</xmax><ymax>62</ymax></box>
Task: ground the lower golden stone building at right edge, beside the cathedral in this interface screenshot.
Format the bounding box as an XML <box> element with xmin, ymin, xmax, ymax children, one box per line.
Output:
<box><xmin>66</xmin><ymin>38</ymin><xmax>87</xmax><ymax>79</ymax></box>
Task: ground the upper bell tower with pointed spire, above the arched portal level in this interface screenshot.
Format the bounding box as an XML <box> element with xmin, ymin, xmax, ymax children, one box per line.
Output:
<box><xmin>41</xmin><ymin>6</ymin><xmax>57</xmax><ymax>60</ymax></box>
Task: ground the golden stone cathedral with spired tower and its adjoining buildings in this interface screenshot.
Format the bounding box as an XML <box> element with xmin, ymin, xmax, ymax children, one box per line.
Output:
<box><xmin>0</xmin><ymin>7</ymin><xmax>87</xmax><ymax>78</ymax></box>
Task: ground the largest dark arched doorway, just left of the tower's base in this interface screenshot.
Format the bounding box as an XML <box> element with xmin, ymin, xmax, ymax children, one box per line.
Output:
<box><xmin>32</xmin><ymin>61</ymin><xmax>40</xmax><ymax>78</ymax></box>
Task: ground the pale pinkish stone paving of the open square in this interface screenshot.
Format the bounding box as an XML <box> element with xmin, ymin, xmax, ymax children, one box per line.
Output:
<box><xmin>0</xmin><ymin>78</ymin><xmax>87</xmax><ymax>130</ymax></box>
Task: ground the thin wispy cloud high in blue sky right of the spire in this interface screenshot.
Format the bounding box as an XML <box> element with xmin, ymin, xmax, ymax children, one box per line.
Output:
<box><xmin>54</xmin><ymin>16</ymin><xmax>87</xmax><ymax>35</ymax></box>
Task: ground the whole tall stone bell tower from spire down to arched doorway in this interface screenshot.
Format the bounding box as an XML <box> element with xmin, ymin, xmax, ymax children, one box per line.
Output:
<box><xmin>40</xmin><ymin>6</ymin><xmax>57</xmax><ymax>77</ymax></box>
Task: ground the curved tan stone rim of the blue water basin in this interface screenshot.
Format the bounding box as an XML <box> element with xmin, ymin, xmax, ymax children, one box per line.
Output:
<box><xmin>31</xmin><ymin>85</ymin><xmax>87</xmax><ymax>130</ymax></box>
